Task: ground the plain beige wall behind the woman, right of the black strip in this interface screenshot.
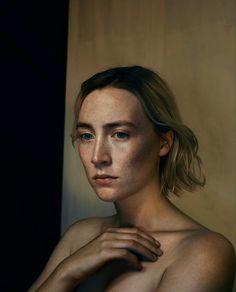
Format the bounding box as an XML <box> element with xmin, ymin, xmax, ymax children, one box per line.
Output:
<box><xmin>62</xmin><ymin>0</ymin><xmax>236</xmax><ymax>251</ymax></box>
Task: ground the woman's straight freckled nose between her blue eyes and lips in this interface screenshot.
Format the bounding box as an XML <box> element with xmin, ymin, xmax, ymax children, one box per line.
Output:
<box><xmin>91</xmin><ymin>140</ymin><xmax>112</xmax><ymax>168</ymax></box>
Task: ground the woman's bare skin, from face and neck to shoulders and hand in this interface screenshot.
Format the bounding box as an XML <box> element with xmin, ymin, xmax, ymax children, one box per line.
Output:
<box><xmin>29</xmin><ymin>87</ymin><xmax>235</xmax><ymax>292</ymax></box>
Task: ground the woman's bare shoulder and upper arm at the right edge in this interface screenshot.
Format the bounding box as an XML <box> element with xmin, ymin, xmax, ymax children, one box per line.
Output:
<box><xmin>157</xmin><ymin>233</ymin><xmax>235</xmax><ymax>292</ymax></box>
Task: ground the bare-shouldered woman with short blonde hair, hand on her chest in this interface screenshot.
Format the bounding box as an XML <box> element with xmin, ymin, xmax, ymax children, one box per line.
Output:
<box><xmin>29</xmin><ymin>66</ymin><xmax>235</xmax><ymax>292</ymax></box>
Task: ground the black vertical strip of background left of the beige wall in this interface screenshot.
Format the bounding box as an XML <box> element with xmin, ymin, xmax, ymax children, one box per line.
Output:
<box><xmin>0</xmin><ymin>0</ymin><xmax>68</xmax><ymax>292</ymax></box>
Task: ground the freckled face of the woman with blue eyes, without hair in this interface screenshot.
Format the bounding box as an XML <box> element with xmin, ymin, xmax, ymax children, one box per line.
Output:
<box><xmin>77</xmin><ymin>87</ymin><xmax>160</xmax><ymax>202</ymax></box>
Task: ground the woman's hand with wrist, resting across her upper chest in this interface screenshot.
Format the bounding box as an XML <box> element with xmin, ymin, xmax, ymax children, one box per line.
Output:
<box><xmin>62</xmin><ymin>228</ymin><xmax>163</xmax><ymax>284</ymax></box>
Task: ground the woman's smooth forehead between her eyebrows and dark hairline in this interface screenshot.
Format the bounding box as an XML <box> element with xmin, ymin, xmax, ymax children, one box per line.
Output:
<box><xmin>79</xmin><ymin>87</ymin><xmax>147</xmax><ymax>123</ymax></box>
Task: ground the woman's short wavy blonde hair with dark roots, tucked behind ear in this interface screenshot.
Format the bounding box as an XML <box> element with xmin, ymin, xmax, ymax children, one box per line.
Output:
<box><xmin>71</xmin><ymin>66</ymin><xmax>205</xmax><ymax>196</ymax></box>
